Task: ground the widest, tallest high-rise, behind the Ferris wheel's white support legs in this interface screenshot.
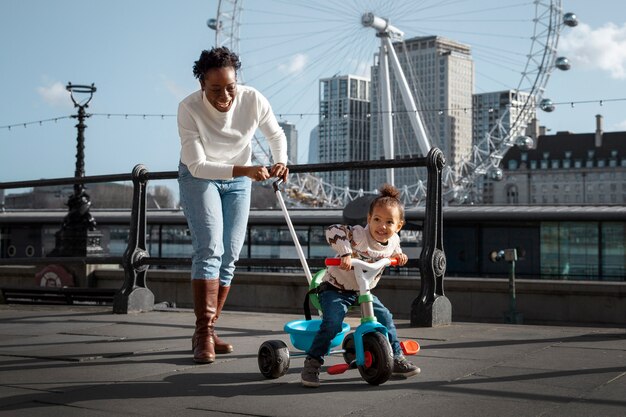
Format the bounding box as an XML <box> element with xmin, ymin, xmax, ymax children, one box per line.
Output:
<box><xmin>370</xmin><ymin>36</ymin><xmax>474</xmax><ymax>188</ymax></box>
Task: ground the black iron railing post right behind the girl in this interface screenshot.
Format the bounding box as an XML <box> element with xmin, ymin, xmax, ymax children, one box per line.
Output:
<box><xmin>411</xmin><ymin>148</ymin><xmax>452</xmax><ymax>327</ymax></box>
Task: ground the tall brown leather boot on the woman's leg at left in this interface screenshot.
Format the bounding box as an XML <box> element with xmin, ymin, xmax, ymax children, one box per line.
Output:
<box><xmin>191</xmin><ymin>279</ymin><xmax>219</xmax><ymax>363</ymax></box>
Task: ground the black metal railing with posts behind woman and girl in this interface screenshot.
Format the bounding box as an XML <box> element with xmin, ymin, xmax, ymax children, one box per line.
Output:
<box><xmin>0</xmin><ymin>148</ymin><xmax>451</xmax><ymax>326</ymax></box>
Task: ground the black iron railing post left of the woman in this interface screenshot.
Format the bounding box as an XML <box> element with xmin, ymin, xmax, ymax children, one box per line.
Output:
<box><xmin>113</xmin><ymin>164</ymin><xmax>154</xmax><ymax>314</ymax></box>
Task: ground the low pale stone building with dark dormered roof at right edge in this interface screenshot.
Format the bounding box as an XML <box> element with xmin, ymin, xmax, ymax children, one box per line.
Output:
<box><xmin>485</xmin><ymin>116</ymin><xmax>626</xmax><ymax>205</ymax></box>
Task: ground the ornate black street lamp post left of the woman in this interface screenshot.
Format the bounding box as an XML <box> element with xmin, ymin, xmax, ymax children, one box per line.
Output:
<box><xmin>50</xmin><ymin>83</ymin><xmax>103</xmax><ymax>256</ymax></box>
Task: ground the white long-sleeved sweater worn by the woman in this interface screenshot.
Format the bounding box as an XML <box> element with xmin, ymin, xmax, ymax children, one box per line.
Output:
<box><xmin>178</xmin><ymin>85</ymin><xmax>287</xmax><ymax>179</ymax></box>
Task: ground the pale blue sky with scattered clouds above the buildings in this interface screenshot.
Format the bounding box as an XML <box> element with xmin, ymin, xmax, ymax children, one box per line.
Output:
<box><xmin>0</xmin><ymin>0</ymin><xmax>626</xmax><ymax>197</ymax></box>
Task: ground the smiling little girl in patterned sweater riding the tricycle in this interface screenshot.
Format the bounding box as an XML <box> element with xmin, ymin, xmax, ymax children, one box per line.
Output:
<box><xmin>301</xmin><ymin>184</ymin><xmax>420</xmax><ymax>387</ymax></box>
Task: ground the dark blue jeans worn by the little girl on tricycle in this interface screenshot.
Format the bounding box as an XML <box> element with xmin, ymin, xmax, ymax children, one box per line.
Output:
<box><xmin>307</xmin><ymin>289</ymin><xmax>402</xmax><ymax>363</ymax></box>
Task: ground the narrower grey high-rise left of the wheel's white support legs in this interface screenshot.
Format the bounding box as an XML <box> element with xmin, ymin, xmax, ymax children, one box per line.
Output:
<box><xmin>318</xmin><ymin>75</ymin><xmax>370</xmax><ymax>190</ymax></box>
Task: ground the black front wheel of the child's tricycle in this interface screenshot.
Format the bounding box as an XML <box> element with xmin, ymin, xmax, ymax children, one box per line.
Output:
<box><xmin>358</xmin><ymin>332</ymin><xmax>393</xmax><ymax>385</ymax></box>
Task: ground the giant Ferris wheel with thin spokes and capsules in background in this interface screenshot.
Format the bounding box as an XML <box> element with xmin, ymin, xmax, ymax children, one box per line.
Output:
<box><xmin>208</xmin><ymin>0</ymin><xmax>577</xmax><ymax>206</ymax></box>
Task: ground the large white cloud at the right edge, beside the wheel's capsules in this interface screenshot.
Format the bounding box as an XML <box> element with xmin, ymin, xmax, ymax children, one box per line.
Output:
<box><xmin>559</xmin><ymin>23</ymin><xmax>626</xmax><ymax>79</ymax></box>
